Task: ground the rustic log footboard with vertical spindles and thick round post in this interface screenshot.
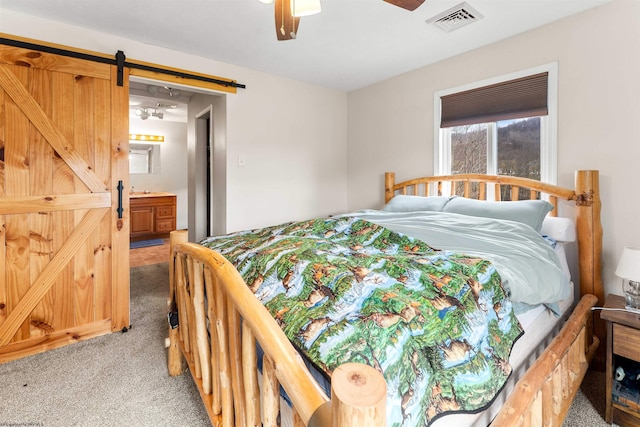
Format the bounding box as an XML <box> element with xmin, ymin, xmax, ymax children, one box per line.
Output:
<box><xmin>168</xmin><ymin>230</ymin><xmax>386</xmax><ymax>427</ymax></box>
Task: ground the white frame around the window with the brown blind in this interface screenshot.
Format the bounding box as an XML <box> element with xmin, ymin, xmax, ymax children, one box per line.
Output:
<box><xmin>433</xmin><ymin>62</ymin><xmax>558</xmax><ymax>184</ymax></box>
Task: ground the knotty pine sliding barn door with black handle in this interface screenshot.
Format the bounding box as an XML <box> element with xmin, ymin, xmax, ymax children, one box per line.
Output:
<box><xmin>0</xmin><ymin>45</ymin><xmax>129</xmax><ymax>362</ymax></box>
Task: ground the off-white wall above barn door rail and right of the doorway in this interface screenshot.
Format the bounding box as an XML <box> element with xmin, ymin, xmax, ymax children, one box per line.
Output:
<box><xmin>0</xmin><ymin>9</ymin><xmax>347</xmax><ymax>237</ymax></box>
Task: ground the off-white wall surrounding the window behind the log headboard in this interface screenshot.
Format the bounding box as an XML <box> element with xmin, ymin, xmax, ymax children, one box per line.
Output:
<box><xmin>348</xmin><ymin>0</ymin><xmax>640</xmax><ymax>300</ymax></box>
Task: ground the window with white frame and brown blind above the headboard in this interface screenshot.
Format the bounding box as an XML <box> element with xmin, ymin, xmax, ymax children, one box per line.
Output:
<box><xmin>434</xmin><ymin>64</ymin><xmax>557</xmax><ymax>195</ymax></box>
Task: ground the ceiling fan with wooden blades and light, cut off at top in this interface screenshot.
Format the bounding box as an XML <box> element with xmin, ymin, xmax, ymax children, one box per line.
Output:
<box><xmin>260</xmin><ymin>0</ymin><xmax>424</xmax><ymax>40</ymax></box>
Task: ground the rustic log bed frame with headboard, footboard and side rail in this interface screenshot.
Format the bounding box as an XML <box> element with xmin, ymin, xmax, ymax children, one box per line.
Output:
<box><xmin>167</xmin><ymin>171</ymin><xmax>604</xmax><ymax>427</ymax></box>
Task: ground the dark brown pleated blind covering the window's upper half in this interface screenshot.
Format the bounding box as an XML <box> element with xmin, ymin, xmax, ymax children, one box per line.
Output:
<box><xmin>440</xmin><ymin>72</ymin><xmax>548</xmax><ymax>128</ymax></box>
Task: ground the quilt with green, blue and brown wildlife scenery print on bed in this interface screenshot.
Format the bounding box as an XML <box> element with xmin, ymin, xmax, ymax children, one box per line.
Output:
<box><xmin>201</xmin><ymin>217</ymin><xmax>522</xmax><ymax>426</ymax></box>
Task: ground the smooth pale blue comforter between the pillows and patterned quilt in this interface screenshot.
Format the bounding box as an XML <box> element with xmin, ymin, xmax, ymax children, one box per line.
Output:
<box><xmin>344</xmin><ymin>210</ymin><xmax>571</xmax><ymax>305</ymax></box>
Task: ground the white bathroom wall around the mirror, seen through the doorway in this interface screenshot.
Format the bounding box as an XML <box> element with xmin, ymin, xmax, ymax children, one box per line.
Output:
<box><xmin>129</xmin><ymin>118</ymin><xmax>188</xmax><ymax>229</ymax></box>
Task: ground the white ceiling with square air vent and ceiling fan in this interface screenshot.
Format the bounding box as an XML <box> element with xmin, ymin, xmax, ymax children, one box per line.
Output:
<box><xmin>0</xmin><ymin>0</ymin><xmax>611</xmax><ymax>91</ymax></box>
